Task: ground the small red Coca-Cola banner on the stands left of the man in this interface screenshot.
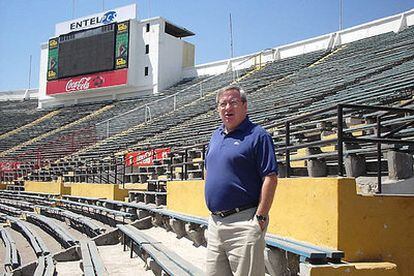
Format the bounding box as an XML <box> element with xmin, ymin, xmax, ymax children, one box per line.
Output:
<box><xmin>125</xmin><ymin>148</ymin><xmax>171</xmax><ymax>167</ymax></box>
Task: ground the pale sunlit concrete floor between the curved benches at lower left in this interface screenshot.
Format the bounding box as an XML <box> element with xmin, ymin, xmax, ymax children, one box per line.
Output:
<box><xmin>0</xmin><ymin>204</ymin><xmax>206</xmax><ymax>276</ymax></box>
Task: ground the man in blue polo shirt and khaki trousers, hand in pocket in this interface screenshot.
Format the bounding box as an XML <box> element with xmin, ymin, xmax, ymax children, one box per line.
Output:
<box><xmin>205</xmin><ymin>86</ymin><xmax>277</xmax><ymax>276</ymax></box>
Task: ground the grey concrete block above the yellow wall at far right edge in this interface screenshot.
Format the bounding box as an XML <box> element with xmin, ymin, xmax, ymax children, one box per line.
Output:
<box><xmin>387</xmin><ymin>150</ymin><xmax>413</xmax><ymax>179</ymax></box>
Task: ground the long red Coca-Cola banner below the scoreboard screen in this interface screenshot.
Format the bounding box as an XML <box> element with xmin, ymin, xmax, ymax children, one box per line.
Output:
<box><xmin>46</xmin><ymin>69</ymin><xmax>128</xmax><ymax>95</ymax></box>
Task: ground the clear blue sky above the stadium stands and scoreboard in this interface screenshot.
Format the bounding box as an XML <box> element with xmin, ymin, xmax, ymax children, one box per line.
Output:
<box><xmin>0</xmin><ymin>0</ymin><xmax>414</xmax><ymax>92</ymax></box>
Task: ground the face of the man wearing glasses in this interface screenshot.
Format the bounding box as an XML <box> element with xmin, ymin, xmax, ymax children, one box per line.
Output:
<box><xmin>217</xmin><ymin>89</ymin><xmax>247</xmax><ymax>132</ymax></box>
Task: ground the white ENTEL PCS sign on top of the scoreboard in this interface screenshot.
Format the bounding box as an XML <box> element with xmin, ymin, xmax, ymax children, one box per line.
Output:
<box><xmin>55</xmin><ymin>4</ymin><xmax>137</xmax><ymax>36</ymax></box>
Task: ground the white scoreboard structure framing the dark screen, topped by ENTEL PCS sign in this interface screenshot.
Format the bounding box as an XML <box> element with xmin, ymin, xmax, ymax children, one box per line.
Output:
<box><xmin>39</xmin><ymin>4</ymin><xmax>195</xmax><ymax>108</ymax></box>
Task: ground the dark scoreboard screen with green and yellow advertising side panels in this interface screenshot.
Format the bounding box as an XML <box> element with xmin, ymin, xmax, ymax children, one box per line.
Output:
<box><xmin>47</xmin><ymin>21</ymin><xmax>129</xmax><ymax>81</ymax></box>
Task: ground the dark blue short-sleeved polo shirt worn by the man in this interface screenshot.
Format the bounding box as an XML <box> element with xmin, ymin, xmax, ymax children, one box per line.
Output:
<box><xmin>205</xmin><ymin>117</ymin><xmax>277</xmax><ymax>212</ymax></box>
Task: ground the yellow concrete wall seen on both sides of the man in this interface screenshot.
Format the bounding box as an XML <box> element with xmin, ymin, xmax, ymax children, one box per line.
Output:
<box><xmin>167</xmin><ymin>178</ymin><xmax>414</xmax><ymax>275</ymax></box>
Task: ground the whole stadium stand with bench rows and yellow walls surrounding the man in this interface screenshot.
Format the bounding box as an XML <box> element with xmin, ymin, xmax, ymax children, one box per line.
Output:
<box><xmin>0</xmin><ymin>9</ymin><xmax>414</xmax><ymax>275</ymax></box>
